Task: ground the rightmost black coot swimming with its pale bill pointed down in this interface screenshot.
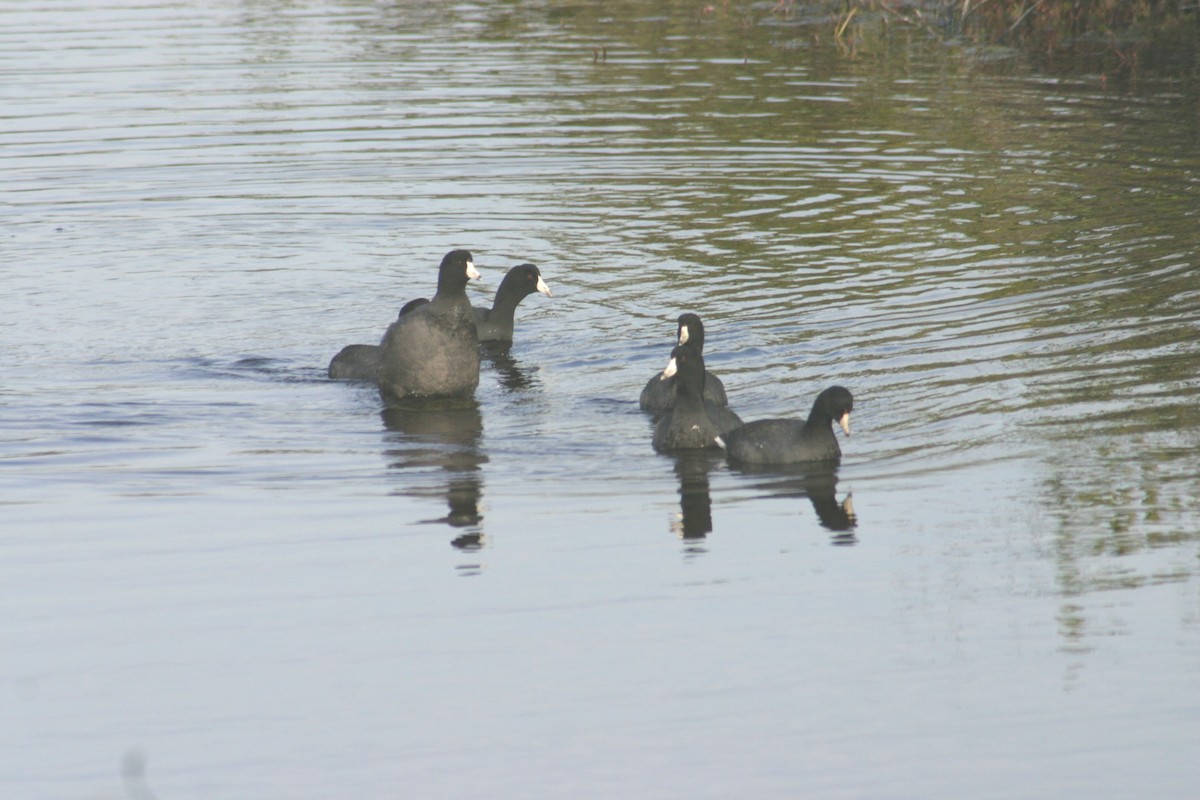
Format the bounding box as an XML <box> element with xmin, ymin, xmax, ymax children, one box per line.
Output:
<box><xmin>720</xmin><ymin>386</ymin><xmax>854</xmax><ymax>464</ymax></box>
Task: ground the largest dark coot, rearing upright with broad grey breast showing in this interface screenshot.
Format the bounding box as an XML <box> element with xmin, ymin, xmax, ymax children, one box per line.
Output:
<box><xmin>379</xmin><ymin>249</ymin><xmax>479</xmax><ymax>399</ymax></box>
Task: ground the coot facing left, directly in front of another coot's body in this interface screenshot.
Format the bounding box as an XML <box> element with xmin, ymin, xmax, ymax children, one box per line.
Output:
<box><xmin>654</xmin><ymin>344</ymin><xmax>742</xmax><ymax>451</ymax></box>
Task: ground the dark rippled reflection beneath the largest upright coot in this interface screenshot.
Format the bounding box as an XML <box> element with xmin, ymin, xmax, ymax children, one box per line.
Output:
<box><xmin>382</xmin><ymin>399</ymin><xmax>487</xmax><ymax>551</ymax></box>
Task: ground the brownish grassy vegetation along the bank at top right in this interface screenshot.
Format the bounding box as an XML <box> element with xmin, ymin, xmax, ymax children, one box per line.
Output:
<box><xmin>773</xmin><ymin>0</ymin><xmax>1200</xmax><ymax>77</ymax></box>
